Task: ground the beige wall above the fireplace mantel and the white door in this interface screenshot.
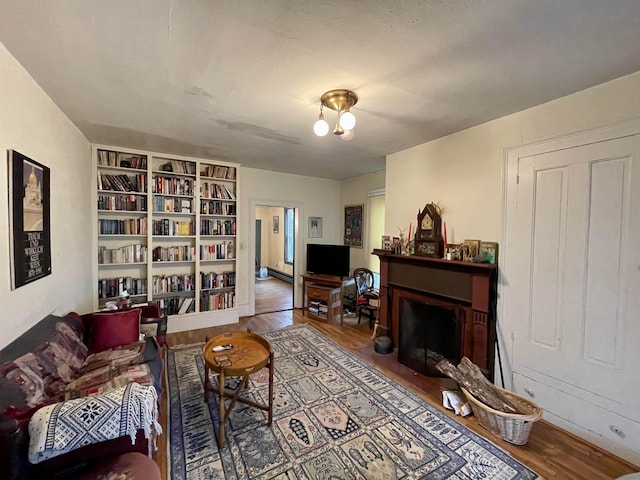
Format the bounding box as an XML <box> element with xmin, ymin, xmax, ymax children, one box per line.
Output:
<box><xmin>385</xmin><ymin>72</ymin><xmax>640</xmax><ymax>243</ymax></box>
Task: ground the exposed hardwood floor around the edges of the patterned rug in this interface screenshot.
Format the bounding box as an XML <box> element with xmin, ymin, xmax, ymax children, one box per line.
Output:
<box><xmin>157</xmin><ymin>309</ymin><xmax>640</xmax><ymax>480</ymax></box>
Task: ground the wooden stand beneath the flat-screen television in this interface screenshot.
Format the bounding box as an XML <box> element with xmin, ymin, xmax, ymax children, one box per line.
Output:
<box><xmin>302</xmin><ymin>274</ymin><xmax>355</xmax><ymax>325</ymax></box>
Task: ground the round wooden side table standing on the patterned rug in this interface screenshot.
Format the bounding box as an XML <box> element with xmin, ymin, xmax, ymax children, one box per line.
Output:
<box><xmin>202</xmin><ymin>332</ymin><xmax>273</xmax><ymax>447</ymax></box>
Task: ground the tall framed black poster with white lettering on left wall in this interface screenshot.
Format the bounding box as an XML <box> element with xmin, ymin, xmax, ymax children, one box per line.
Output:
<box><xmin>9</xmin><ymin>150</ymin><xmax>51</xmax><ymax>289</ymax></box>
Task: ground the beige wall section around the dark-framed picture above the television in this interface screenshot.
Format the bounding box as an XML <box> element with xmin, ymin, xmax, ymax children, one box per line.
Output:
<box><xmin>340</xmin><ymin>170</ymin><xmax>385</xmax><ymax>271</ymax></box>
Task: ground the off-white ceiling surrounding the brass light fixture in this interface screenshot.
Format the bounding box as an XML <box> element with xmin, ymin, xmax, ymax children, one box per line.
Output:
<box><xmin>0</xmin><ymin>0</ymin><xmax>640</xmax><ymax>179</ymax></box>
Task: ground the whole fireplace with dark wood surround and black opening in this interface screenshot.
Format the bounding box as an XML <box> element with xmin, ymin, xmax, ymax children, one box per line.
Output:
<box><xmin>374</xmin><ymin>250</ymin><xmax>497</xmax><ymax>380</ymax></box>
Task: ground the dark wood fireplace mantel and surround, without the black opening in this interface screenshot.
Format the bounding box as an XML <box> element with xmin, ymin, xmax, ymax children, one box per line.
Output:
<box><xmin>373</xmin><ymin>249</ymin><xmax>498</xmax><ymax>379</ymax></box>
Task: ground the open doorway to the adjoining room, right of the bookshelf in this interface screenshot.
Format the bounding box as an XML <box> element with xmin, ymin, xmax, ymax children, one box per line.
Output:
<box><xmin>255</xmin><ymin>205</ymin><xmax>296</xmax><ymax>315</ymax></box>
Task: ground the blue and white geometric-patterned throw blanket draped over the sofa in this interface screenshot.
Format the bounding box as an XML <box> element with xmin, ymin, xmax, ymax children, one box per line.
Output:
<box><xmin>29</xmin><ymin>383</ymin><xmax>162</xmax><ymax>463</ymax></box>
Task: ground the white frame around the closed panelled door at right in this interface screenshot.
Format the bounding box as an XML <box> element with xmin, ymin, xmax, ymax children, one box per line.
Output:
<box><xmin>495</xmin><ymin>120</ymin><xmax>640</xmax><ymax>390</ymax></box>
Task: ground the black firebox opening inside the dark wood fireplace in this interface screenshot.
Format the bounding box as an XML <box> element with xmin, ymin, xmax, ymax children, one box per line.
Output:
<box><xmin>398</xmin><ymin>299</ymin><xmax>463</xmax><ymax>377</ymax></box>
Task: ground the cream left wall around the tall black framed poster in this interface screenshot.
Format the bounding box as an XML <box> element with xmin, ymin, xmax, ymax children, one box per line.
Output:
<box><xmin>0</xmin><ymin>44</ymin><xmax>93</xmax><ymax>348</ymax></box>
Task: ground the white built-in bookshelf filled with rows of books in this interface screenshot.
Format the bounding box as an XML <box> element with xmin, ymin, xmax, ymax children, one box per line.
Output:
<box><xmin>93</xmin><ymin>145</ymin><xmax>238</xmax><ymax>331</ymax></box>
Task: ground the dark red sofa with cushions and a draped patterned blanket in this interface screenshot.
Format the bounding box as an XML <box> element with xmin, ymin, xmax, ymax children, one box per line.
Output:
<box><xmin>0</xmin><ymin>309</ymin><xmax>166</xmax><ymax>480</ymax></box>
